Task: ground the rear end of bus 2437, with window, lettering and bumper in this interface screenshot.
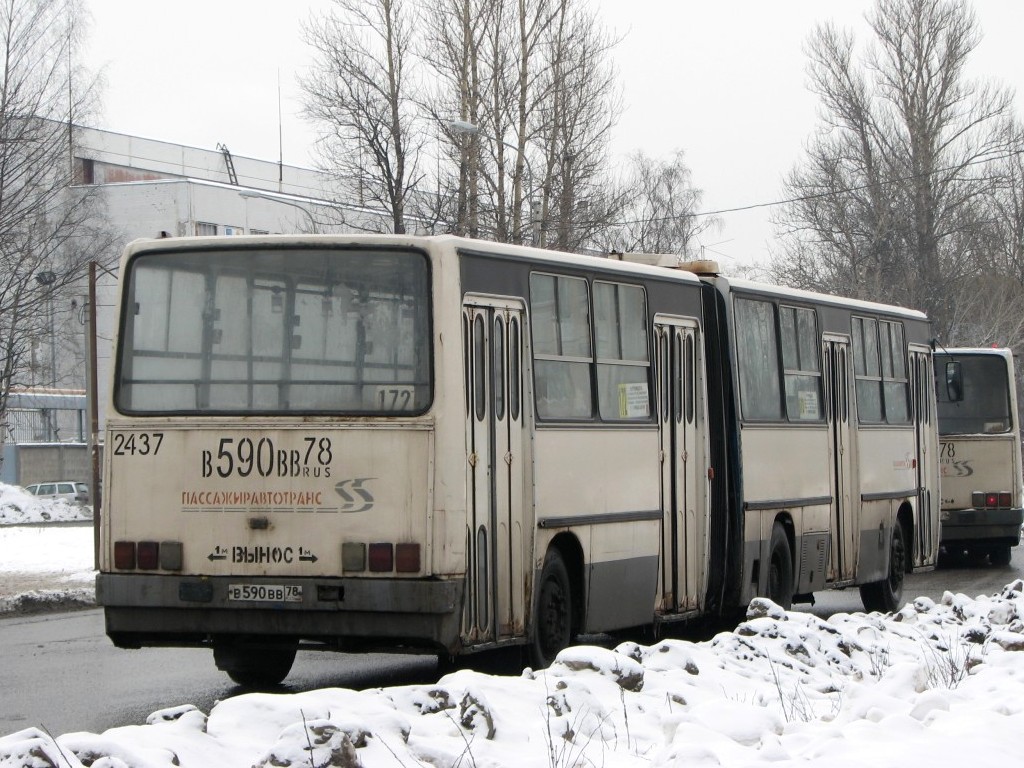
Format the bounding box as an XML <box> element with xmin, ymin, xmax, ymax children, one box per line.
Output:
<box><xmin>97</xmin><ymin>238</ymin><xmax>461</xmax><ymax>684</ymax></box>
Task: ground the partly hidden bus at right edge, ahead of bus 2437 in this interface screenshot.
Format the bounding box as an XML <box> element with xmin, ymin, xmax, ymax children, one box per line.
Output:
<box><xmin>935</xmin><ymin>347</ymin><xmax>1024</xmax><ymax>565</ymax></box>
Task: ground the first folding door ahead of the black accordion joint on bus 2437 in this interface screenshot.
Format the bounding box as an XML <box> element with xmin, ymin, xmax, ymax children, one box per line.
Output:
<box><xmin>822</xmin><ymin>334</ymin><xmax>860</xmax><ymax>582</ymax></box>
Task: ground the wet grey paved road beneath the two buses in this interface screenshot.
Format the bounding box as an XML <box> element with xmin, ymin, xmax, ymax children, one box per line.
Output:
<box><xmin>0</xmin><ymin>548</ymin><xmax>1024</xmax><ymax>735</ymax></box>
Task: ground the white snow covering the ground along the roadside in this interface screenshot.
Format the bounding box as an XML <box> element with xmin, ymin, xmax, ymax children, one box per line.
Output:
<box><xmin>0</xmin><ymin>489</ymin><xmax>1024</xmax><ymax>768</ymax></box>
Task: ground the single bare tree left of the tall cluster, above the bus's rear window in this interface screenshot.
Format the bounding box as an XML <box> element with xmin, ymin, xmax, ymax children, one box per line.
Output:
<box><xmin>301</xmin><ymin>0</ymin><xmax>425</xmax><ymax>233</ymax></box>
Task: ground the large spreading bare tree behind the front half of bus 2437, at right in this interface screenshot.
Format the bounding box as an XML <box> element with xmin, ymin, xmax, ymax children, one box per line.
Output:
<box><xmin>773</xmin><ymin>0</ymin><xmax>1011</xmax><ymax>338</ymax></box>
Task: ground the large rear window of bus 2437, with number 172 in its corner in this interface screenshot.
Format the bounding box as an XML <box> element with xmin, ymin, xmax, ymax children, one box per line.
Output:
<box><xmin>115</xmin><ymin>246</ymin><xmax>432</xmax><ymax>415</ymax></box>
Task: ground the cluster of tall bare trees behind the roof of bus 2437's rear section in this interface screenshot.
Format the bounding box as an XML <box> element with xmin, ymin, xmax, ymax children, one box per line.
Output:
<box><xmin>423</xmin><ymin>0</ymin><xmax>620</xmax><ymax>249</ymax></box>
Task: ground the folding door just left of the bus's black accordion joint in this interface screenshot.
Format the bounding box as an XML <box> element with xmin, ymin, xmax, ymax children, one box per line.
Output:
<box><xmin>654</xmin><ymin>315</ymin><xmax>709</xmax><ymax>613</ymax></box>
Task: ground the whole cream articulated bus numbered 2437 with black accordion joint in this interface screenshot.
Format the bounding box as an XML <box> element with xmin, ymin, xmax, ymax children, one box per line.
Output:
<box><xmin>97</xmin><ymin>236</ymin><xmax>938</xmax><ymax>685</ymax></box>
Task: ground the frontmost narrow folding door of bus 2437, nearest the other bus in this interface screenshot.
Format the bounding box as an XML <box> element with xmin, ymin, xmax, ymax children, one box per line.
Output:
<box><xmin>908</xmin><ymin>344</ymin><xmax>939</xmax><ymax>565</ymax></box>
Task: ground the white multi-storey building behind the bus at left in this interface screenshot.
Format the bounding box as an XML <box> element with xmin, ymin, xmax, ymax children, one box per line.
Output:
<box><xmin>6</xmin><ymin>126</ymin><xmax>415</xmax><ymax>483</ymax></box>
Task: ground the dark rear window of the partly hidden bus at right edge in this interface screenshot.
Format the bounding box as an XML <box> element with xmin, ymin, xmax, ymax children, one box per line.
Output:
<box><xmin>935</xmin><ymin>354</ymin><xmax>1013</xmax><ymax>435</ymax></box>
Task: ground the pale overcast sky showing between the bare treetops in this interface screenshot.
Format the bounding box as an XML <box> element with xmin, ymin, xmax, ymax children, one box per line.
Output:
<box><xmin>86</xmin><ymin>0</ymin><xmax>1024</xmax><ymax>266</ymax></box>
